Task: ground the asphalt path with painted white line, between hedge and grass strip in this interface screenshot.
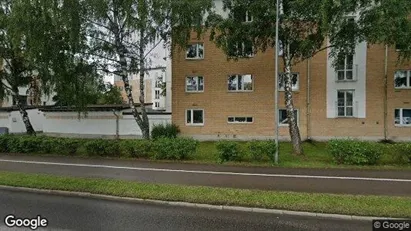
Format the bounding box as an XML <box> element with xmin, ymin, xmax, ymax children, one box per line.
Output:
<box><xmin>0</xmin><ymin>155</ymin><xmax>411</xmax><ymax>196</ymax></box>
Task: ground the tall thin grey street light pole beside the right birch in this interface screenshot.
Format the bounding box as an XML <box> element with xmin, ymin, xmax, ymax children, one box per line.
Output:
<box><xmin>274</xmin><ymin>0</ymin><xmax>280</xmax><ymax>164</ymax></box>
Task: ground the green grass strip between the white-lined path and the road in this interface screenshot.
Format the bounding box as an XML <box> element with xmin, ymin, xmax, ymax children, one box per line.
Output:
<box><xmin>0</xmin><ymin>172</ymin><xmax>411</xmax><ymax>218</ymax></box>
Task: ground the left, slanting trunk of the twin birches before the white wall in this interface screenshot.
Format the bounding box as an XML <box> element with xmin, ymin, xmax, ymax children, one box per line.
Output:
<box><xmin>114</xmin><ymin>9</ymin><xmax>150</xmax><ymax>139</ymax></box>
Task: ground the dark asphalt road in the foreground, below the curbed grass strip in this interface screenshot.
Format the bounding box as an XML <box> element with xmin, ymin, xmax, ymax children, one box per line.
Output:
<box><xmin>0</xmin><ymin>190</ymin><xmax>372</xmax><ymax>231</ymax></box>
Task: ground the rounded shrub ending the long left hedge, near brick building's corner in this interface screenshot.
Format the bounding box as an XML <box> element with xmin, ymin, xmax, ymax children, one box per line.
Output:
<box><xmin>152</xmin><ymin>137</ymin><xmax>198</xmax><ymax>160</ymax></box>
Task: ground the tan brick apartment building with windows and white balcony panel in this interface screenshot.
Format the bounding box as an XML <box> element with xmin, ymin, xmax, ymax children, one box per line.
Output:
<box><xmin>172</xmin><ymin>9</ymin><xmax>411</xmax><ymax>140</ymax></box>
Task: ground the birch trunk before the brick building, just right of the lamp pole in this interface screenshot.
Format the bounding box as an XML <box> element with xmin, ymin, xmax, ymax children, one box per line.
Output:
<box><xmin>283</xmin><ymin>52</ymin><xmax>304</xmax><ymax>155</ymax></box>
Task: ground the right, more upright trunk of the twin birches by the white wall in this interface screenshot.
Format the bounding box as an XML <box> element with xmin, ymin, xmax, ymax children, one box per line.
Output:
<box><xmin>139</xmin><ymin>29</ymin><xmax>150</xmax><ymax>139</ymax></box>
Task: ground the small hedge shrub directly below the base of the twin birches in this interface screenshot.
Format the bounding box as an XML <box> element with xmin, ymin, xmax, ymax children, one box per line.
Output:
<box><xmin>119</xmin><ymin>140</ymin><xmax>152</xmax><ymax>158</ymax></box>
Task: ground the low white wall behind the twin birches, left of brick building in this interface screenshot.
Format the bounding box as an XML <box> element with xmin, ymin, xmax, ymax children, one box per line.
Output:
<box><xmin>43</xmin><ymin>112</ymin><xmax>171</xmax><ymax>138</ymax></box>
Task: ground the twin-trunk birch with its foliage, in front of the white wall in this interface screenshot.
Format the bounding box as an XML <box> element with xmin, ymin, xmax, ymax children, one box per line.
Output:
<box><xmin>84</xmin><ymin>0</ymin><xmax>212</xmax><ymax>139</ymax></box>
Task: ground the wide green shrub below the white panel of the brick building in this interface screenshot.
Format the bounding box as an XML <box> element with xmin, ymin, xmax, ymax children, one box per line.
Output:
<box><xmin>327</xmin><ymin>139</ymin><xmax>383</xmax><ymax>165</ymax></box>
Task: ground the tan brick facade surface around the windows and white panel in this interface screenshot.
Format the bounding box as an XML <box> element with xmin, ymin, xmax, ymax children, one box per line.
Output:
<box><xmin>172</xmin><ymin>31</ymin><xmax>411</xmax><ymax>140</ymax></box>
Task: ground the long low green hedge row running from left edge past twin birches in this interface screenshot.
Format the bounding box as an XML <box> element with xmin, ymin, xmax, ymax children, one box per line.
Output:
<box><xmin>0</xmin><ymin>135</ymin><xmax>198</xmax><ymax>160</ymax></box>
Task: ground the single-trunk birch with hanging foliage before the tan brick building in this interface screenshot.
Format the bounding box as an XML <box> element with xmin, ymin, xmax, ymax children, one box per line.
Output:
<box><xmin>208</xmin><ymin>0</ymin><xmax>411</xmax><ymax>155</ymax></box>
